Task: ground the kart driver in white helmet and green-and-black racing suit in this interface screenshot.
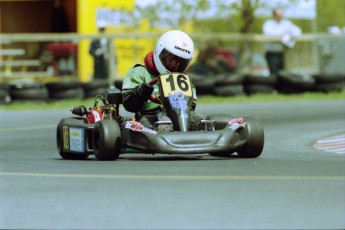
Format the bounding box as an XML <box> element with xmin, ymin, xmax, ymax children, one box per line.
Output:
<box><xmin>122</xmin><ymin>30</ymin><xmax>202</xmax><ymax>129</ymax></box>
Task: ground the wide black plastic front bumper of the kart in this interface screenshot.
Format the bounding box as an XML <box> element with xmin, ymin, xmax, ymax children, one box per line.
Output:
<box><xmin>122</xmin><ymin>125</ymin><xmax>246</xmax><ymax>154</ymax></box>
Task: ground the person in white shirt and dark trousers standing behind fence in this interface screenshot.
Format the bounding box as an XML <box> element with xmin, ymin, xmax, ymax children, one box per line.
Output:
<box><xmin>262</xmin><ymin>8</ymin><xmax>302</xmax><ymax>74</ymax></box>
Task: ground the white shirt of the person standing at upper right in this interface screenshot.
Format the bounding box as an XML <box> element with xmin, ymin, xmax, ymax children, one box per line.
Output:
<box><xmin>262</xmin><ymin>19</ymin><xmax>302</xmax><ymax>52</ymax></box>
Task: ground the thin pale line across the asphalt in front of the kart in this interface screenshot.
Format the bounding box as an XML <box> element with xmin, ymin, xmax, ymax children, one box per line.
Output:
<box><xmin>0</xmin><ymin>172</ymin><xmax>345</xmax><ymax>181</ymax></box>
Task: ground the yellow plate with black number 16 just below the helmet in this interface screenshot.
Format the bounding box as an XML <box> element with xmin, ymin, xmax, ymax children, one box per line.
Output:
<box><xmin>160</xmin><ymin>73</ymin><xmax>192</xmax><ymax>97</ymax></box>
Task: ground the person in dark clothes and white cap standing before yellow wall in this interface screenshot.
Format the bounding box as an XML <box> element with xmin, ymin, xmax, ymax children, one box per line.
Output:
<box><xmin>89</xmin><ymin>21</ymin><xmax>109</xmax><ymax>79</ymax></box>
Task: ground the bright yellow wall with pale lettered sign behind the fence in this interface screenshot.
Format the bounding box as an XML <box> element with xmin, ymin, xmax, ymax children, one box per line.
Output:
<box><xmin>77</xmin><ymin>0</ymin><xmax>192</xmax><ymax>82</ymax></box>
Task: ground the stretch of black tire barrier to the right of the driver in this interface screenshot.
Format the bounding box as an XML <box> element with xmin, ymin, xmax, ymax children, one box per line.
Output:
<box><xmin>192</xmin><ymin>71</ymin><xmax>345</xmax><ymax>96</ymax></box>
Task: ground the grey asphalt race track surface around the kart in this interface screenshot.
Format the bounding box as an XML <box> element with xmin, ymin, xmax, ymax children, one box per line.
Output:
<box><xmin>0</xmin><ymin>101</ymin><xmax>345</xmax><ymax>229</ymax></box>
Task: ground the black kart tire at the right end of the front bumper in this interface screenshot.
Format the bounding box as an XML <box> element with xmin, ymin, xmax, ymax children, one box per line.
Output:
<box><xmin>237</xmin><ymin>117</ymin><xmax>264</xmax><ymax>158</ymax></box>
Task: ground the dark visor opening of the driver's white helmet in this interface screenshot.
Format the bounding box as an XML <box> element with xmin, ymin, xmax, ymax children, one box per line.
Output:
<box><xmin>159</xmin><ymin>49</ymin><xmax>191</xmax><ymax>72</ymax></box>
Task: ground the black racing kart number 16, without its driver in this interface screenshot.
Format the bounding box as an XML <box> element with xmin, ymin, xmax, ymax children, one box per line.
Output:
<box><xmin>56</xmin><ymin>73</ymin><xmax>264</xmax><ymax>160</ymax></box>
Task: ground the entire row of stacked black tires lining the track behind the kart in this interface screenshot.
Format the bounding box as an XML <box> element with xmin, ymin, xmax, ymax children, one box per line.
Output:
<box><xmin>0</xmin><ymin>71</ymin><xmax>345</xmax><ymax>105</ymax></box>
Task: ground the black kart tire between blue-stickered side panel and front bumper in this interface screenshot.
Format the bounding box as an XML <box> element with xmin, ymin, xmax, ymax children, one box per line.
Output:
<box><xmin>92</xmin><ymin>120</ymin><xmax>121</xmax><ymax>161</ymax></box>
